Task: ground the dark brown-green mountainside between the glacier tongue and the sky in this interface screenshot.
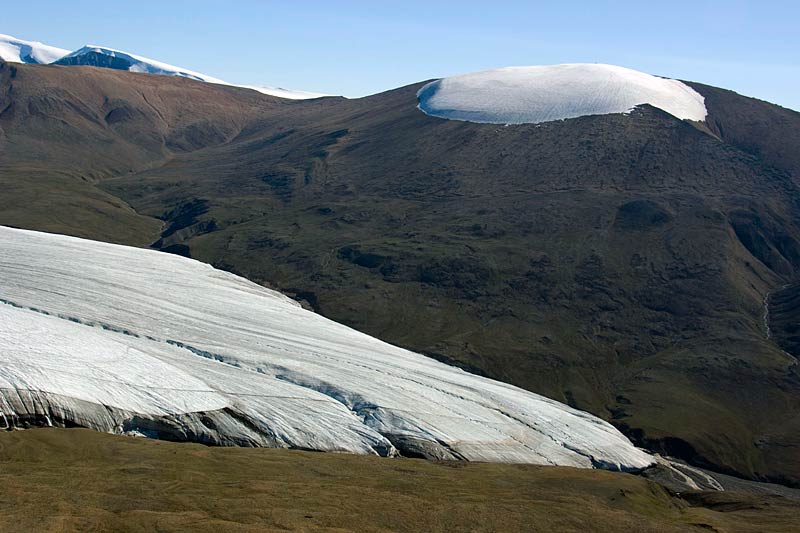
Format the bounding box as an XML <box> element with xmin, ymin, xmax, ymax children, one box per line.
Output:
<box><xmin>0</xmin><ymin>61</ymin><xmax>800</xmax><ymax>483</ymax></box>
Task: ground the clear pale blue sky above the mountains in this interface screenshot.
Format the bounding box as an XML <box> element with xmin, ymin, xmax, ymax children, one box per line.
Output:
<box><xmin>6</xmin><ymin>0</ymin><xmax>800</xmax><ymax>110</ymax></box>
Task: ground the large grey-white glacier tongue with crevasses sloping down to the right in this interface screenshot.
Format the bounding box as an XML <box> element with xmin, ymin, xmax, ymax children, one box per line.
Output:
<box><xmin>0</xmin><ymin>227</ymin><xmax>653</xmax><ymax>470</ymax></box>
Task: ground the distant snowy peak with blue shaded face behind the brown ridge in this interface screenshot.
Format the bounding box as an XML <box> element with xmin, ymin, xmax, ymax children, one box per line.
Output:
<box><xmin>55</xmin><ymin>45</ymin><xmax>227</xmax><ymax>85</ymax></box>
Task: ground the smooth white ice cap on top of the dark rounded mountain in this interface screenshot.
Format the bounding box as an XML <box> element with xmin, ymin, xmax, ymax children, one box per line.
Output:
<box><xmin>417</xmin><ymin>63</ymin><xmax>707</xmax><ymax>124</ymax></box>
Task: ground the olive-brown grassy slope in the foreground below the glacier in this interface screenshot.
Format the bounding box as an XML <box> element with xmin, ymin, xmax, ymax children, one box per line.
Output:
<box><xmin>0</xmin><ymin>429</ymin><xmax>798</xmax><ymax>531</ymax></box>
